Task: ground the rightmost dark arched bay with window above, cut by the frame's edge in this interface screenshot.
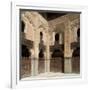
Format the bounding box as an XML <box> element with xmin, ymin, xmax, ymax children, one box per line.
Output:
<box><xmin>72</xmin><ymin>28</ymin><xmax>80</xmax><ymax>73</ymax></box>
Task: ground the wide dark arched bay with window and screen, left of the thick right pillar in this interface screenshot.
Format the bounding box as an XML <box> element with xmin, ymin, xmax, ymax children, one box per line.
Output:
<box><xmin>50</xmin><ymin>33</ymin><xmax>64</xmax><ymax>72</ymax></box>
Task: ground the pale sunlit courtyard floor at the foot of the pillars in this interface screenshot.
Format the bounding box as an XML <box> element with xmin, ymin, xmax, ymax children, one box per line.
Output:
<box><xmin>21</xmin><ymin>72</ymin><xmax>80</xmax><ymax>80</ymax></box>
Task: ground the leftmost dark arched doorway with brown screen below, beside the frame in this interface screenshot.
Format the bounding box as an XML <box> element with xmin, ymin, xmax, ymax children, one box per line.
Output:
<box><xmin>20</xmin><ymin>45</ymin><xmax>31</xmax><ymax>78</ymax></box>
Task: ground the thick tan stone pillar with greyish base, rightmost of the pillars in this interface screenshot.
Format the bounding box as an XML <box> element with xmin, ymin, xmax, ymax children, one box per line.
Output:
<box><xmin>64</xmin><ymin>22</ymin><xmax>72</xmax><ymax>73</ymax></box>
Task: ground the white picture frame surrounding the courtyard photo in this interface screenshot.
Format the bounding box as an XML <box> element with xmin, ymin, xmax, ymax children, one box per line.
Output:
<box><xmin>11</xmin><ymin>2</ymin><xmax>87</xmax><ymax>88</ymax></box>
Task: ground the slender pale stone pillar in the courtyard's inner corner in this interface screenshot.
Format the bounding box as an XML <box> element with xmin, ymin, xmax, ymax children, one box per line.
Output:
<box><xmin>45</xmin><ymin>33</ymin><xmax>50</xmax><ymax>72</ymax></box>
